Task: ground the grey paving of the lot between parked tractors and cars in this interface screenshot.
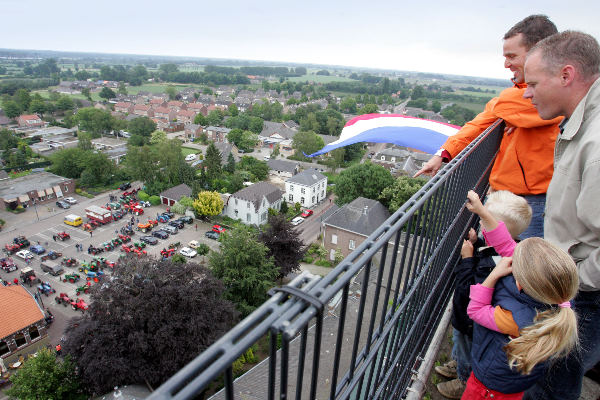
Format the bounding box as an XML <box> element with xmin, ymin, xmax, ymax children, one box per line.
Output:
<box><xmin>0</xmin><ymin>192</ymin><xmax>219</xmax><ymax>354</ymax></box>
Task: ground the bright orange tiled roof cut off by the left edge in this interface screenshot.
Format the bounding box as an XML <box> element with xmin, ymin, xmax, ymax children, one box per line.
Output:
<box><xmin>0</xmin><ymin>285</ymin><xmax>44</xmax><ymax>339</ymax></box>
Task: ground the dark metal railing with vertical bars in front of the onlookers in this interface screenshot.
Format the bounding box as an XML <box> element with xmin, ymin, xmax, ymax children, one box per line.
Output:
<box><xmin>150</xmin><ymin>120</ymin><xmax>504</xmax><ymax>400</ymax></box>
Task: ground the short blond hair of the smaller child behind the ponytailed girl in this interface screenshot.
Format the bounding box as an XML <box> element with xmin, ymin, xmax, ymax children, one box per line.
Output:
<box><xmin>485</xmin><ymin>190</ymin><xmax>531</xmax><ymax>239</ymax></box>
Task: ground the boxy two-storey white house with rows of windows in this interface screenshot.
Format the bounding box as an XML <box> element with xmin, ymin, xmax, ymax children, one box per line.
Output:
<box><xmin>285</xmin><ymin>168</ymin><xmax>327</xmax><ymax>208</ymax></box>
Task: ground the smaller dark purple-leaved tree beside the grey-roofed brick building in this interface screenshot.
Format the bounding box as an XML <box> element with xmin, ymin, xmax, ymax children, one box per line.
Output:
<box><xmin>258</xmin><ymin>216</ymin><xmax>306</xmax><ymax>279</ymax></box>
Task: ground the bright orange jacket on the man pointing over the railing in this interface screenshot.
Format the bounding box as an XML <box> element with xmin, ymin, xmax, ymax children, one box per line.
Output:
<box><xmin>442</xmin><ymin>84</ymin><xmax>562</xmax><ymax>195</ymax></box>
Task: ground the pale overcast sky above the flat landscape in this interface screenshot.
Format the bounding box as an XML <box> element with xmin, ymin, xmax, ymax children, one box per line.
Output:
<box><xmin>0</xmin><ymin>0</ymin><xmax>600</xmax><ymax>79</ymax></box>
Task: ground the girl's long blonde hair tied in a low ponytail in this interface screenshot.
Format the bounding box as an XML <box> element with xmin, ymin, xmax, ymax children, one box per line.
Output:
<box><xmin>504</xmin><ymin>237</ymin><xmax>579</xmax><ymax>374</ymax></box>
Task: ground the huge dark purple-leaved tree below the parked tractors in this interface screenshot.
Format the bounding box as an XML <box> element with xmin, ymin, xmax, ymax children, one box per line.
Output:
<box><xmin>63</xmin><ymin>257</ymin><xmax>237</xmax><ymax>394</ymax></box>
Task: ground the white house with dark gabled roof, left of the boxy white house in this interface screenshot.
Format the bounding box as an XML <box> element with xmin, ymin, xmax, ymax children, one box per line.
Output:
<box><xmin>223</xmin><ymin>182</ymin><xmax>283</xmax><ymax>225</ymax></box>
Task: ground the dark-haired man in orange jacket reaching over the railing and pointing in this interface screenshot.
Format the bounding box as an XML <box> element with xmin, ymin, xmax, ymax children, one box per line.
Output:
<box><xmin>415</xmin><ymin>15</ymin><xmax>562</xmax><ymax>239</ymax></box>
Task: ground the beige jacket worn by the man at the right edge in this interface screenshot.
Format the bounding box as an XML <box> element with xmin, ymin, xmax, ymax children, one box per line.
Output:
<box><xmin>544</xmin><ymin>79</ymin><xmax>600</xmax><ymax>291</ymax></box>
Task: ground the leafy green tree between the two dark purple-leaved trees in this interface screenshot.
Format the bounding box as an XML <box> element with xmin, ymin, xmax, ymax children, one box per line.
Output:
<box><xmin>209</xmin><ymin>226</ymin><xmax>278</xmax><ymax>317</ymax></box>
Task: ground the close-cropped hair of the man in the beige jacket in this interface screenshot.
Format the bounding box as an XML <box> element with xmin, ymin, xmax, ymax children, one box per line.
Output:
<box><xmin>529</xmin><ymin>31</ymin><xmax>600</xmax><ymax>80</ymax></box>
